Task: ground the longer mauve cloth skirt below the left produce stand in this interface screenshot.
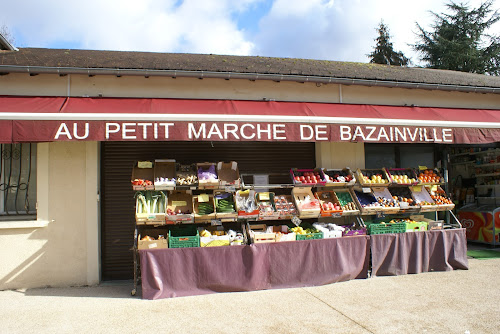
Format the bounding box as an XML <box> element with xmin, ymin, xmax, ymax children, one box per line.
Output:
<box><xmin>139</xmin><ymin>236</ymin><xmax>370</xmax><ymax>299</ymax></box>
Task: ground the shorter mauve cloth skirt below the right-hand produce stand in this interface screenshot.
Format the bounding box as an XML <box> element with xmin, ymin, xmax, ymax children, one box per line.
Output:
<box><xmin>370</xmin><ymin>229</ymin><xmax>469</xmax><ymax>276</ymax></box>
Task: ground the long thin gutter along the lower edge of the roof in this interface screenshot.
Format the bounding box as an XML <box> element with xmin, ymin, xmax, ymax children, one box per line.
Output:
<box><xmin>0</xmin><ymin>65</ymin><xmax>500</xmax><ymax>94</ymax></box>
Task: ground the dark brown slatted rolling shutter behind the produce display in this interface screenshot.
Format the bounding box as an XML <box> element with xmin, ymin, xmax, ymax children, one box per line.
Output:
<box><xmin>101</xmin><ymin>142</ymin><xmax>316</xmax><ymax>280</ymax></box>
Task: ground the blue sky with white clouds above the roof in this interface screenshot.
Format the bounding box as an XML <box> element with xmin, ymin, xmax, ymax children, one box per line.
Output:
<box><xmin>0</xmin><ymin>0</ymin><xmax>500</xmax><ymax>65</ymax></box>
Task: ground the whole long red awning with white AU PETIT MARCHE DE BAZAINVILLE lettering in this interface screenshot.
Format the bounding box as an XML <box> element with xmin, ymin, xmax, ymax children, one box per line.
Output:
<box><xmin>0</xmin><ymin>96</ymin><xmax>500</xmax><ymax>143</ymax></box>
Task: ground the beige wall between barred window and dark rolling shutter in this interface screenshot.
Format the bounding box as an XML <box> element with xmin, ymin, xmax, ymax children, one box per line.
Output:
<box><xmin>0</xmin><ymin>142</ymin><xmax>99</xmax><ymax>289</ymax></box>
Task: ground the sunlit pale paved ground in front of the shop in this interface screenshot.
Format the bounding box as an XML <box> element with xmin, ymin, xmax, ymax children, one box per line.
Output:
<box><xmin>0</xmin><ymin>249</ymin><xmax>500</xmax><ymax>334</ymax></box>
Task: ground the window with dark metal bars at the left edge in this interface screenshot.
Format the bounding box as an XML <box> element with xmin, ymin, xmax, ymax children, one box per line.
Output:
<box><xmin>0</xmin><ymin>143</ymin><xmax>36</xmax><ymax>220</ymax></box>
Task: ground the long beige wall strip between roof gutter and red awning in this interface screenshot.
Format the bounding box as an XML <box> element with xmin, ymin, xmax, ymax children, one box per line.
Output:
<box><xmin>0</xmin><ymin>73</ymin><xmax>500</xmax><ymax>109</ymax></box>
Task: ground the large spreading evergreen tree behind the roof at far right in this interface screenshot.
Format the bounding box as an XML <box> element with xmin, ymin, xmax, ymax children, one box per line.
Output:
<box><xmin>413</xmin><ymin>0</ymin><xmax>500</xmax><ymax>75</ymax></box>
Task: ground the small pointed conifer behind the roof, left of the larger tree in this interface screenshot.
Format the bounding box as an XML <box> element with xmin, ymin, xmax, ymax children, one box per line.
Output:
<box><xmin>368</xmin><ymin>22</ymin><xmax>410</xmax><ymax>66</ymax></box>
